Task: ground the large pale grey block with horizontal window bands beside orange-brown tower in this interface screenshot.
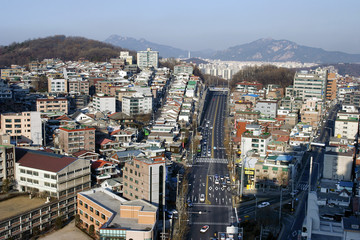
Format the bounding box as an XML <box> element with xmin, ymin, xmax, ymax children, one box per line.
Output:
<box><xmin>293</xmin><ymin>68</ymin><xmax>328</xmax><ymax>100</ymax></box>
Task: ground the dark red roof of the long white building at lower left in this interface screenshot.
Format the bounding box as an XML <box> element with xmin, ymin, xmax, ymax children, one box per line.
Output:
<box><xmin>16</xmin><ymin>148</ymin><xmax>77</xmax><ymax>173</ymax></box>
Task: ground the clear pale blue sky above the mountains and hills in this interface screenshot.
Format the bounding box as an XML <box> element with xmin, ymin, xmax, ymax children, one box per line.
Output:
<box><xmin>0</xmin><ymin>0</ymin><xmax>360</xmax><ymax>54</ymax></box>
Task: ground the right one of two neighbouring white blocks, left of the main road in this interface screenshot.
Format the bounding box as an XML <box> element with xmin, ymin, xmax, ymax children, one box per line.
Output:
<box><xmin>122</xmin><ymin>93</ymin><xmax>152</xmax><ymax>116</ymax></box>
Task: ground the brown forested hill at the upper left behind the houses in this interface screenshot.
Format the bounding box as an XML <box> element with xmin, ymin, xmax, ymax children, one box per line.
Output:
<box><xmin>0</xmin><ymin>35</ymin><xmax>135</xmax><ymax>68</ymax></box>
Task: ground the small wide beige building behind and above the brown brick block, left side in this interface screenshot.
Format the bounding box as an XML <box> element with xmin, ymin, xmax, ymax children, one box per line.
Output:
<box><xmin>36</xmin><ymin>97</ymin><xmax>69</xmax><ymax>114</ymax></box>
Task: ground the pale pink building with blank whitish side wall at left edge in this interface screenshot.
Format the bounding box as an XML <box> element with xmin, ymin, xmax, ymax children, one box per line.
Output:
<box><xmin>0</xmin><ymin>112</ymin><xmax>43</xmax><ymax>145</ymax></box>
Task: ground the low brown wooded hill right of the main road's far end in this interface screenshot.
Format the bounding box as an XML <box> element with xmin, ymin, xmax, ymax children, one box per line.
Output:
<box><xmin>230</xmin><ymin>65</ymin><xmax>295</xmax><ymax>88</ymax></box>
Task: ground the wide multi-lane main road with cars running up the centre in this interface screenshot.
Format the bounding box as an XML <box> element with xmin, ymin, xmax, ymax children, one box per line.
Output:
<box><xmin>188</xmin><ymin>92</ymin><xmax>236</xmax><ymax>240</ymax></box>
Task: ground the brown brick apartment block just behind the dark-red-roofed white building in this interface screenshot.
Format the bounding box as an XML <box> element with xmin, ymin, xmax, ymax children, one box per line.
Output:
<box><xmin>58</xmin><ymin>126</ymin><xmax>95</xmax><ymax>154</ymax></box>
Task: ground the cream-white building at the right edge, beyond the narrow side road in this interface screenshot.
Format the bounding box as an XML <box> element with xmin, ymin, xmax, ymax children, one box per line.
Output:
<box><xmin>334</xmin><ymin>112</ymin><xmax>359</xmax><ymax>140</ymax></box>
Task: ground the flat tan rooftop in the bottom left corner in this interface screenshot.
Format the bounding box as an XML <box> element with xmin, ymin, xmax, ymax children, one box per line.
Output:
<box><xmin>0</xmin><ymin>195</ymin><xmax>46</xmax><ymax>221</ymax></box>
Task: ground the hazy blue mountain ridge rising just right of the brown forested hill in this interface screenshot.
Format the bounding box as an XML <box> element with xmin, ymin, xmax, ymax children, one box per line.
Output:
<box><xmin>104</xmin><ymin>35</ymin><xmax>188</xmax><ymax>58</ymax></box>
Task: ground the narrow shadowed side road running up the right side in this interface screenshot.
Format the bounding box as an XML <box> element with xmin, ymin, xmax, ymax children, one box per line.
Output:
<box><xmin>281</xmin><ymin>105</ymin><xmax>339</xmax><ymax>240</ymax></box>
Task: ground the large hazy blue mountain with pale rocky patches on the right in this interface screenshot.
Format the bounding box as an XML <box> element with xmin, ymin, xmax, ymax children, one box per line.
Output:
<box><xmin>210</xmin><ymin>38</ymin><xmax>360</xmax><ymax>63</ymax></box>
